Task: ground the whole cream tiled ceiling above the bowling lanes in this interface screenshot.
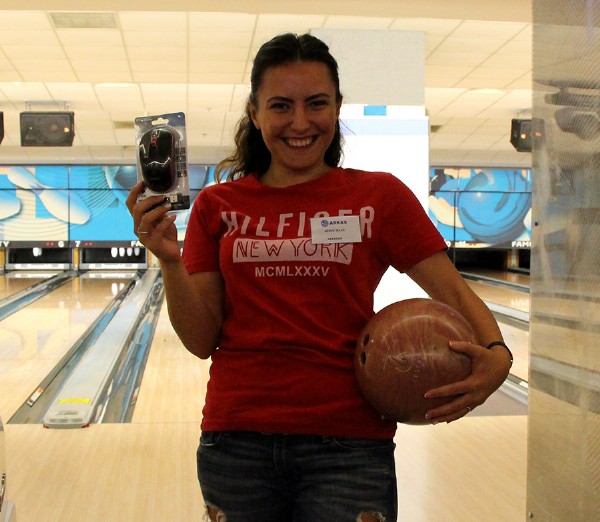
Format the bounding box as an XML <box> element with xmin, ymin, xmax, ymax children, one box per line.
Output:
<box><xmin>0</xmin><ymin>0</ymin><xmax>536</xmax><ymax>167</ymax></box>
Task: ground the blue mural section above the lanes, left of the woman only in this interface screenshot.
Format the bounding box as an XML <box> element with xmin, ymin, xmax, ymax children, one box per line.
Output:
<box><xmin>0</xmin><ymin>165</ymin><xmax>214</xmax><ymax>268</ymax></box>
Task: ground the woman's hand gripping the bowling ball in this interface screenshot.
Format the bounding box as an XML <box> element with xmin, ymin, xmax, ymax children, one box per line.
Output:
<box><xmin>425</xmin><ymin>341</ymin><xmax>511</xmax><ymax>424</ymax></box>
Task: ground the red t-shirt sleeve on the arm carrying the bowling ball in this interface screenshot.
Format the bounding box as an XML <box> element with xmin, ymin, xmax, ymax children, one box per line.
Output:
<box><xmin>378</xmin><ymin>174</ymin><xmax>447</xmax><ymax>272</ymax></box>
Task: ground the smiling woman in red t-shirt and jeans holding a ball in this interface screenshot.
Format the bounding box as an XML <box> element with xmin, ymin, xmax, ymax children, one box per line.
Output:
<box><xmin>128</xmin><ymin>34</ymin><xmax>511</xmax><ymax>522</ymax></box>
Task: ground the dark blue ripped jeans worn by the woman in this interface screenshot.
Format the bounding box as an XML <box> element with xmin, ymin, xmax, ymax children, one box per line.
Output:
<box><xmin>197</xmin><ymin>432</ymin><xmax>398</xmax><ymax>522</ymax></box>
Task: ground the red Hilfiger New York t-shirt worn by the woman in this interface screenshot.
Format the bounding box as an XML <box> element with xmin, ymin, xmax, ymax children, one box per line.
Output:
<box><xmin>183</xmin><ymin>168</ymin><xmax>445</xmax><ymax>439</ymax></box>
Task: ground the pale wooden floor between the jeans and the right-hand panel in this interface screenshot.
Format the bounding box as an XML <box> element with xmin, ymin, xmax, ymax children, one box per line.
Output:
<box><xmin>395</xmin><ymin>415</ymin><xmax>527</xmax><ymax>522</ymax></box>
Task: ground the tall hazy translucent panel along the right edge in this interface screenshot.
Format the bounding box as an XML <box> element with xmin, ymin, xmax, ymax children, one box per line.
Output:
<box><xmin>528</xmin><ymin>0</ymin><xmax>600</xmax><ymax>521</ymax></box>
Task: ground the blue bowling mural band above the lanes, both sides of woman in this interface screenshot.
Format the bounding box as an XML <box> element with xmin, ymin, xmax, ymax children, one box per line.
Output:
<box><xmin>0</xmin><ymin>165</ymin><xmax>531</xmax><ymax>268</ymax></box>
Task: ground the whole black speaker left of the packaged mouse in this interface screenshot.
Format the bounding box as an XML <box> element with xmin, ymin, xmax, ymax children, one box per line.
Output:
<box><xmin>21</xmin><ymin>112</ymin><xmax>75</xmax><ymax>147</ymax></box>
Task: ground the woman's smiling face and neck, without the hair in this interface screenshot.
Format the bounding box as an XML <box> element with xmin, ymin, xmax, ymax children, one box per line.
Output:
<box><xmin>250</xmin><ymin>62</ymin><xmax>340</xmax><ymax>183</ymax></box>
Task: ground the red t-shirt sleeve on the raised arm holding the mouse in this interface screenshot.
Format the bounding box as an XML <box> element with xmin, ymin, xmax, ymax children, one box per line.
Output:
<box><xmin>183</xmin><ymin>188</ymin><xmax>220</xmax><ymax>274</ymax></box>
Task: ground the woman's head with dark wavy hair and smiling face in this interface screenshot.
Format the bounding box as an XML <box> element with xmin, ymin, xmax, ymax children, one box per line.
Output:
<box><xmin>216</xmin><ymin>34</ymin><xmax>343</xmax><ymax>185</ymax></box>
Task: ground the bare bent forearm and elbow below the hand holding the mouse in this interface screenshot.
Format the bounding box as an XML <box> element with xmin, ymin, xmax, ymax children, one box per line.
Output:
<box><xmin>160</xmin><ymin>260</ymin><xmax>223</xmax><ymax>359</ymax></box>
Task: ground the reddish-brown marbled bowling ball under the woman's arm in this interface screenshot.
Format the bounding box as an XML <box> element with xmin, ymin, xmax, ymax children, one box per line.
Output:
<box><xmin>354</xmin><ymin>298</ymin><xmax>475</xmax><ymax>424</ymax></box>
